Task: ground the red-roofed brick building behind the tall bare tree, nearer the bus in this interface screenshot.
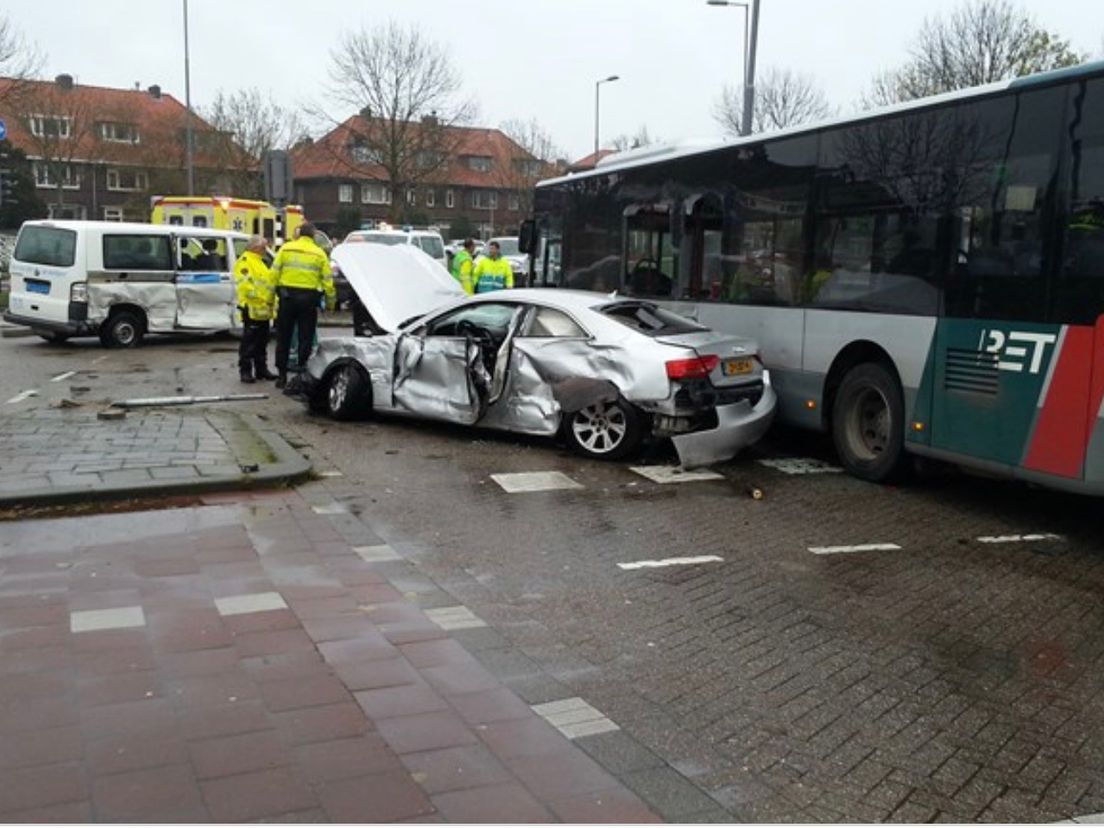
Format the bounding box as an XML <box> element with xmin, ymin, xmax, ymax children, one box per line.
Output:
<box><xmin>293</xmin><ymin>115</ymin><xmax>549</xmax><ymax>238</ymax></box>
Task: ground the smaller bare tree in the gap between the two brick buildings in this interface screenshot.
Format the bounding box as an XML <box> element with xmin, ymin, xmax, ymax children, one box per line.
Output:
<box><xmin>201</xmin><ymin>87</ymin><xmax>307</xmax><ymax>198</ymax></box>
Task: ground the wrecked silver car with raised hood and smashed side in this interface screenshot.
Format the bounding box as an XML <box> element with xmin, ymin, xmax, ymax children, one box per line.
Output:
<box><xmin>298</xmin><ymin>244</ymin><xmax>776</xmax><ymax>468</ymax></box>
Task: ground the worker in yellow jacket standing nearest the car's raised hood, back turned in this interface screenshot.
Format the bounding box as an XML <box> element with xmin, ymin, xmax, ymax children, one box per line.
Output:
<box><xmin>273</xmin><ymin>222</ymin><xmax>337</xmax><ymax>389</ymax></box>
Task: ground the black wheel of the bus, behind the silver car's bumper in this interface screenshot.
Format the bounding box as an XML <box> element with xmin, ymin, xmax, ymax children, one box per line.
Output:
<box><xmin>831</xmin><ymin>362</ymin><xmax>905</xmax><ymax>482</ymax></box>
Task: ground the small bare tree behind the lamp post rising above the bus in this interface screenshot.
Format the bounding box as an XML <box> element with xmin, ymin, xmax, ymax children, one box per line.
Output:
<box><xmin>713</xmin><ymin>68</ymin><xmax>831</xmax><ymax>135</ymax></box>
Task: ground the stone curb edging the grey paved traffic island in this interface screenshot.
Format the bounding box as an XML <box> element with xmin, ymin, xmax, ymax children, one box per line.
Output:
<box><xmin>0</xmin><ymin>414</ymin><xmax>314</xmax><ymax>509</ymax></box>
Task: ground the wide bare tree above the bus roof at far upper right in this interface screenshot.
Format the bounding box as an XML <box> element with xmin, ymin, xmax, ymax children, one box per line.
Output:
<box><xmin>864</xmin><ymin>0</ymin><xmax>1085</xmax><ymax>105</ymax></box>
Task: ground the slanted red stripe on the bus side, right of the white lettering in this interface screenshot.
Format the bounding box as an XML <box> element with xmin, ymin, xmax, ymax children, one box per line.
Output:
<box><xmin>1023</xmin><ymin>327</ymin><xmax>1094</xmax><ymax>478</ymax></box>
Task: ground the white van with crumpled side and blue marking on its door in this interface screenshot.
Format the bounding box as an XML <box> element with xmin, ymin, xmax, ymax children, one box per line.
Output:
<box><xmin>4</xmin><ymin>221</ymin><xmax>248</xmax><ymax>348</ymax></box>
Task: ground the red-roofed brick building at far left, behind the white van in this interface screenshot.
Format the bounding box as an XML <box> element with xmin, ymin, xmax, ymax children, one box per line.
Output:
<box><xmin>0</xmin><ymin>75</ymin><xmax>246</xmax><ymax>221</ymax></box>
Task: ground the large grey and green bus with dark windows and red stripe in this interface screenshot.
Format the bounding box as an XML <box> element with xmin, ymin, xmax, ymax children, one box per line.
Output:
<box><xmin>522</xmin><ymin>63</ymin><xmax>1104</xmax><ymax>493</ymax></box>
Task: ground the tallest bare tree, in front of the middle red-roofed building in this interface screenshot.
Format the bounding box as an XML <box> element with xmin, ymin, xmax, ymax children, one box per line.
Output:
<box><xmin>327</xmin><ymin>21</ymin><xmax>475</xmax><ymax>217</ymax></box>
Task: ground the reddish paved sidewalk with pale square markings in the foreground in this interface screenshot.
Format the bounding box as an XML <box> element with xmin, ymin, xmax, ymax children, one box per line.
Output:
<box><xmin>0</xmin><ymin>492</ymin><xmax>657</xmax><ymax>822</ymax></box>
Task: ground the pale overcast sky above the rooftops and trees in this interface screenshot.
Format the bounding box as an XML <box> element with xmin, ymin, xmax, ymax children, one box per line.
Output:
<box><xmin>3</xmin><ymin>0</ymin><xmax>1104</xmax><ymax>158</ymax></box>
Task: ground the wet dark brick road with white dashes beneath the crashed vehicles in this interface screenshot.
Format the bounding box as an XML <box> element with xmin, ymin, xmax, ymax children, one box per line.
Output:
<box><xmin>0</xmin><ymin>326</ymin><xmax>1104</xmax><ymax>821</ymax></box>
